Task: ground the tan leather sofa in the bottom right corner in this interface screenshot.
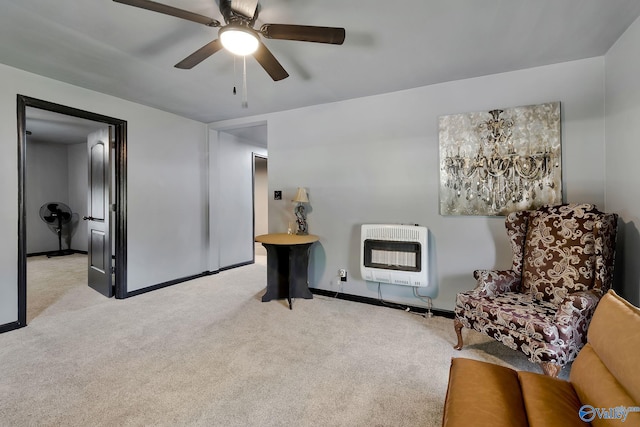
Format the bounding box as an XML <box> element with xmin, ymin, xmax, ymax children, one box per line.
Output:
<box><xmin>443</xmin><ymin>291</ymin><xmax>640</xmax><ymax>427</ymax></box>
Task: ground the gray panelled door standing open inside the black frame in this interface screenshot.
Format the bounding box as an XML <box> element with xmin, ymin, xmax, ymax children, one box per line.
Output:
<box><xmin>84</xmin><ymin>128</ymin><xmax>113</xmax><ymax>297</ymax></box>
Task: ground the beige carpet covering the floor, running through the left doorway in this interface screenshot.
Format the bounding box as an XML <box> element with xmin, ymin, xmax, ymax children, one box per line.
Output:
<box><xmin>0</xmin><ymin>256</ymin><xmax>566</xmax><ymax>426</ymax></box>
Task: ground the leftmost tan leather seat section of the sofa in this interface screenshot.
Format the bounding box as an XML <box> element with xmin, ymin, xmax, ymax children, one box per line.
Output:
<box><xmin>442</xmin><ymin>358</ymin><xmax>527</xmax><ymax>427</ymax></box>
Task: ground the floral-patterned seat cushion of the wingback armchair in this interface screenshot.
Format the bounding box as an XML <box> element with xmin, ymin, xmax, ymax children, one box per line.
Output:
<box><xmin>456</xmin><ymin>292</ymin><xmax>558</xmax><ymax>342</ymax></box>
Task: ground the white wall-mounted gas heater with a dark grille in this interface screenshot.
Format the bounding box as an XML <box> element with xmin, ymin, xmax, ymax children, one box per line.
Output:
<box><xmin>360</xmin><ymin>224</ymin><xmax>429</xmax><ymax>287</ymax></box>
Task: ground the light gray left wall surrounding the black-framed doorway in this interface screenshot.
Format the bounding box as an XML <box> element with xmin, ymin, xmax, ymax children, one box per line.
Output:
<box><xmin>0</xmin><ymin>65</ymin><xmax>207</xmax><ymax>325</ymax></box>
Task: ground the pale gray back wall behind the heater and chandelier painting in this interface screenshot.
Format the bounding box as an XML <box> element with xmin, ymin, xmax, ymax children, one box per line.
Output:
<box><xmin>216</xmin><ymin>57</ymin><xmax>604</xmax><ymax>310</ymax></box>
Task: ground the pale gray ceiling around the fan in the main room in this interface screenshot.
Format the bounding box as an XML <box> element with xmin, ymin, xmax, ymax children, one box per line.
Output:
<box><xmin>0</xmin><ymin>0</ymin><xmax>640</xmax><ymax>127</ymax></box>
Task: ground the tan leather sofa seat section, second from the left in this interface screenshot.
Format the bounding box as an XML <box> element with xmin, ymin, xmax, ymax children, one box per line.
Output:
<box><xmin>518</xmin><ymin>372</ymin><xmax>585</xmax><ymax>427</ymax></box>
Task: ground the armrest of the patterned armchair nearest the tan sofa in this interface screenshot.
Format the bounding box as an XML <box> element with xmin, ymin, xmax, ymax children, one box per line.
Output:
<box><xmin>554</xmin><ymin>290</ymin><xmax>600</xmax><ymax>348</ymax></box>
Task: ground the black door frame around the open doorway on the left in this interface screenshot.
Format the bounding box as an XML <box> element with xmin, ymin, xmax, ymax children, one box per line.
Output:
<box><xmin>17</xmin><ymin>94</ymin><xmax>127</xmax><ymax>328</ymax></box>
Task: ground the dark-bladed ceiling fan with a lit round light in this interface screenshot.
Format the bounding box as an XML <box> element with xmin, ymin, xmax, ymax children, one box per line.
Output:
<box><xmin>113</xmin><ymin>0</ymin><xmax>345</xmax><ymax>81</ymax></box>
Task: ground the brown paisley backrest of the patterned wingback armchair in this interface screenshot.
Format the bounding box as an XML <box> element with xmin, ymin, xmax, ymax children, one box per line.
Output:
<box><xmin>522</xmin><ymin>204</ymin><xmax>601</xmax><ymax>304</ymax></box>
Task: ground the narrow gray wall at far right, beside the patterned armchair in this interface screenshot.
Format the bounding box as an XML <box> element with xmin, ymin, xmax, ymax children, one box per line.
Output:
<box><xmin>605</xmin><ymin>14</ymin><xmax>640</xmax><ymax>305</ymax></box>
